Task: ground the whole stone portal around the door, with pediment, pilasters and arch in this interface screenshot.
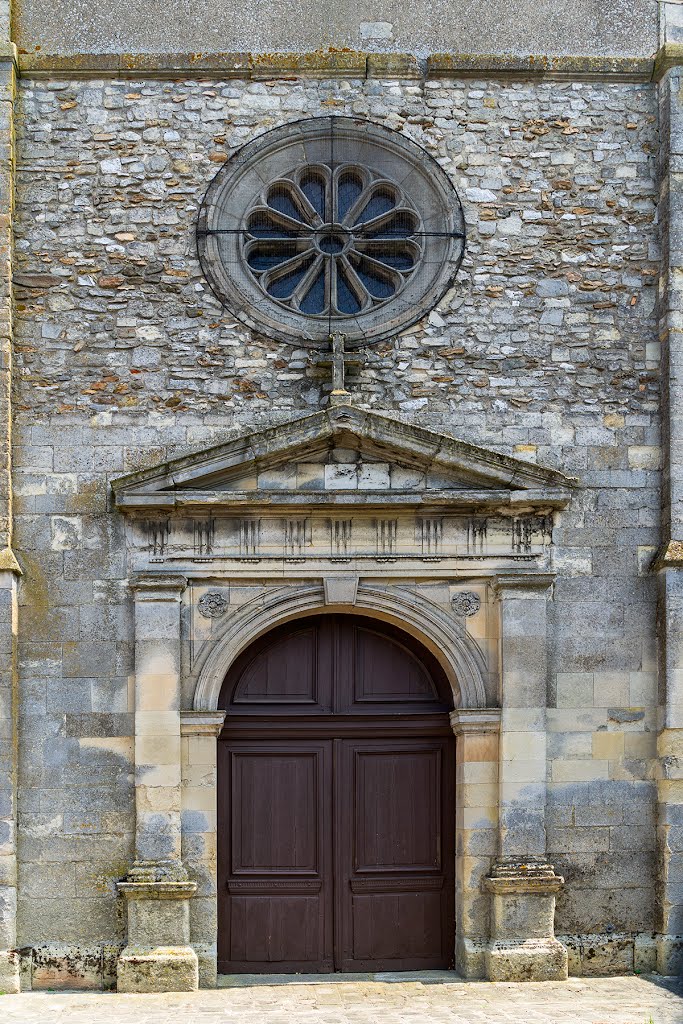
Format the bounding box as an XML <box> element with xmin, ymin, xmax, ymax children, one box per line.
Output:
<box><xmin>115</xmin><ymin>404</ymin><xmax>570</xmax><ymax>987</ymax></box>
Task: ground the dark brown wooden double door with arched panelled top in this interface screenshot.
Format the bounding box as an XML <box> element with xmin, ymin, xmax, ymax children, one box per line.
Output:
<box><xmin>218</xmin><ymin>614</ymin><xmax>455</xmax><ymax>973</ymax></box>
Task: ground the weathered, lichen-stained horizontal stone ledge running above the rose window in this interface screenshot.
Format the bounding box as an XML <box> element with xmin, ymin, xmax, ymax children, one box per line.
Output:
<box><xmin>9</xmin><ymin>45</ymin><xmax>663</xmax><ymax>82</ymax></box>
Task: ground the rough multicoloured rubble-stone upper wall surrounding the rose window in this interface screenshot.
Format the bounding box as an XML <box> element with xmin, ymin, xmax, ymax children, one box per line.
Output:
<box><xmin>15</xmin><ymin>80</ymin><xmax>658</xmax><ymax>417</ymax></box>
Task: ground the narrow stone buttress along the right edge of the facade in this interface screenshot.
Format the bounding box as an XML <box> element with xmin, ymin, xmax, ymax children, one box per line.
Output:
<box><xmin>655</xmin><ymin>41</ymin><xmax>683</xmax><ymax>974</ymax></box>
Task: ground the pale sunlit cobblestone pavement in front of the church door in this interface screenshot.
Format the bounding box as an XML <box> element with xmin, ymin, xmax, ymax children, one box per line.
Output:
<box><xmin>0</xmin><ymin>974</ymin><xmax>683</xmax><ymax>1024</ymax></box>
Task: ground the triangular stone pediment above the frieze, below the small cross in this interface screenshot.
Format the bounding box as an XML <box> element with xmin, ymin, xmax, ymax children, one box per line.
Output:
<box><xmin>113</xmin><ymin>406</ymin><xmax>572</xmax><ymax>510</ymax></box>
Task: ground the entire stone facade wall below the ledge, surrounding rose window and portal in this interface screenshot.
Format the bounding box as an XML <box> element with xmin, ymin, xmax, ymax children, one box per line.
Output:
<box><xmin>14</xmin><ymin>74</ymin><xmax>659</xmax><ymax>986</ymax></box>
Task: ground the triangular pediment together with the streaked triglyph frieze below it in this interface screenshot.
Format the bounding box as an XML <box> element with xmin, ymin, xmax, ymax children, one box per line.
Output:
<box><xmin>114</xmin><ymin>406</ymin><xmax>571</xmax><ymax>577</ymax></box>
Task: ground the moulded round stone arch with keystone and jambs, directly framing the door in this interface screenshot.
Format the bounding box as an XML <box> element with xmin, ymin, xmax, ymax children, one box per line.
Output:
<box><xmin>181</xmin><ymin>575</ymin><xmax>491</xmax><ymax>984</ymax></box>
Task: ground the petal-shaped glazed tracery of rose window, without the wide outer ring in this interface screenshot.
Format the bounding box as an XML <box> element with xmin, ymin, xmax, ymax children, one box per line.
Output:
<box><xmin>243</xmin><ymin>165</ymin><xmax>422</xmax><ymax>317</ymax></box>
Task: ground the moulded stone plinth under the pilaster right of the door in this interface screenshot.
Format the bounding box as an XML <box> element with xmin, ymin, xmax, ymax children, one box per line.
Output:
<box><xmin>482</xmin><ymin>858</ymin><xmax>567</xmax><ymax>981</ymax></box>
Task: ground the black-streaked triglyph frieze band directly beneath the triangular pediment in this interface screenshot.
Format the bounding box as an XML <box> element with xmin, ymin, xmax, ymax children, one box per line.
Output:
<box><xmin>121</xmin><ymin>516</ymin><xmax>552</xmax><ymax>575</ymax></box>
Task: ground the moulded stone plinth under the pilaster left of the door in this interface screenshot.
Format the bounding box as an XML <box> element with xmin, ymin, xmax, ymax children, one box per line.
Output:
<box><xmin>117</xmin><ymin>863</ymin><xmax>199</xmax><ymax>992</ymax></box>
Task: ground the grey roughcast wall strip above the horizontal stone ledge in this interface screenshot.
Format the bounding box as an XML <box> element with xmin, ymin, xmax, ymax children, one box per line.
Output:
<box><xmin>13</xmin><ymin>0</ymin><xmax>655</xmax><ymax>56</ymax></box>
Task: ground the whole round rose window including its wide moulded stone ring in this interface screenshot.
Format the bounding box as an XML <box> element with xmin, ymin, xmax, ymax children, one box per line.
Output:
<box><xmin>198</xmin><ymin>117</ymin><xmax>465</xmax><ymax>347</ymax></box>
